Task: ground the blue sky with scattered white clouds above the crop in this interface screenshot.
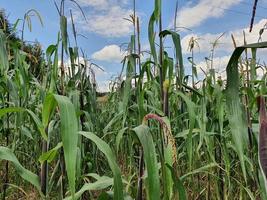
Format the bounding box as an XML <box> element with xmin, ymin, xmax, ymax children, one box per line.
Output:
<box><xmin>0</xmin><ymin>0</ymin><xmax>267</xmax><ymax>90</ymax></box>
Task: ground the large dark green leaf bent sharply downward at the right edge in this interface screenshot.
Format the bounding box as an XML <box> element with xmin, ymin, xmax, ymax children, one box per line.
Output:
<box><xmin>226</xmin><ymin>42</ymin><xmax>267</xmax><ymax>181</ymax></box>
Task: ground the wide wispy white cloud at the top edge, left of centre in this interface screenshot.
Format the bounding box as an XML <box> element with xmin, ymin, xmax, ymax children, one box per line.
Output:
<box><xmin>74</xmin><ymin>0</ymin><xmax>133</xmax><ymax>37</ymax></box>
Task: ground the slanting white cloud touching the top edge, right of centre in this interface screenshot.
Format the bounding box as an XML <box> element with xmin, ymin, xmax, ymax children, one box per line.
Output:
<box><xmin>176</xmin><ymin>0</ymin><xmax>242</xmax><ymax>28</ymax></box>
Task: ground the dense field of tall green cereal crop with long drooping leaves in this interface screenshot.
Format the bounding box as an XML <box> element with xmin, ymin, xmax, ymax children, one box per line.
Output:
<box><xmin>0</xmin><ymin>0</ymin><xmax>267</xmax><ymax>200</ymax></box>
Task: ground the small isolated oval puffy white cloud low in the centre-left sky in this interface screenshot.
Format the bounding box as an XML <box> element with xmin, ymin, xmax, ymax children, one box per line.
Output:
<box><xmin>92</xmin><ymin>45</ymin><xmax>124</xmax><ymax>62</ymax></box>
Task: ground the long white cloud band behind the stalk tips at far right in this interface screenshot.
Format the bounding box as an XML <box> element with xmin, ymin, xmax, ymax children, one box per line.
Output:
<box><xmin>181</xmin><ymin>19</ymin><xmax>267</xmax><ymax>54</ymax></box>
